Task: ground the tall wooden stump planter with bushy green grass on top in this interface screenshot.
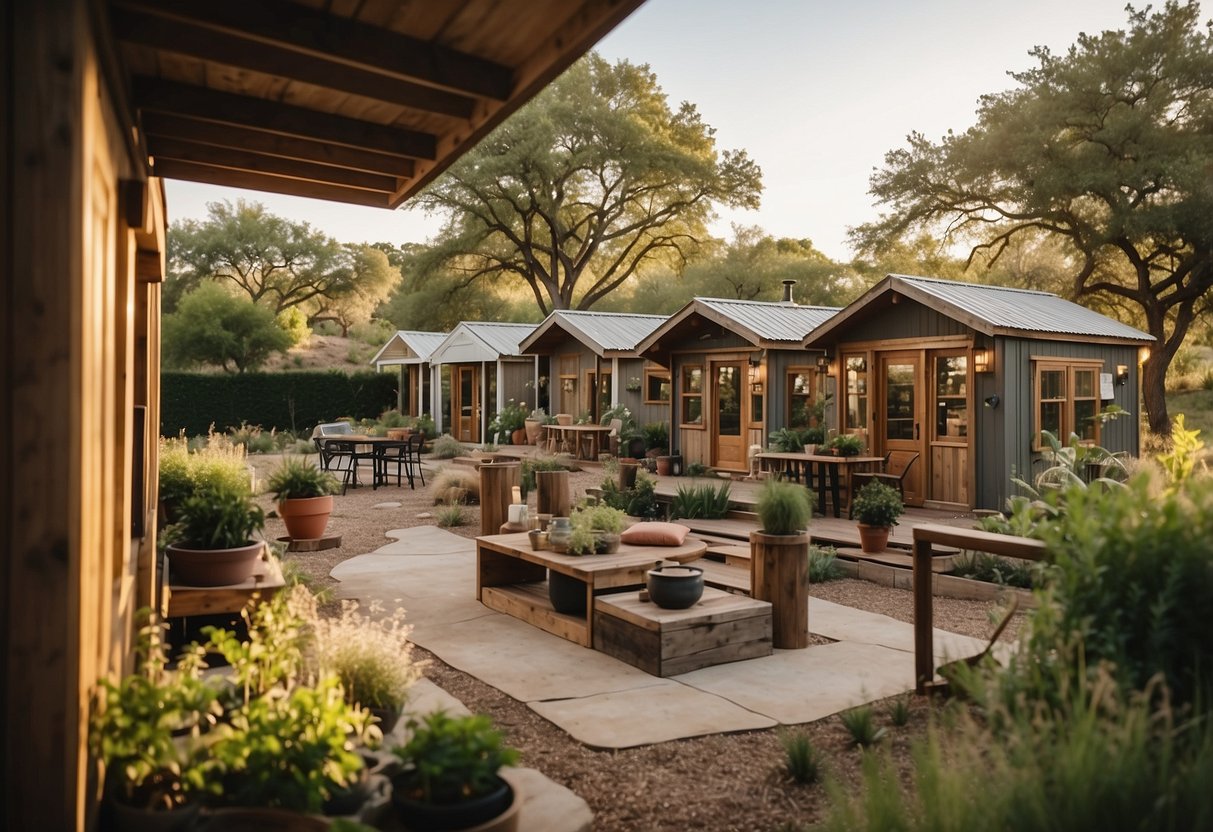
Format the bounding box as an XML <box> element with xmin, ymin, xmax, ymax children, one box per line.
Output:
<box><xmin>750</xmin><ymin>479</ymin><xmax>813</xmax><ymax>649</ymax></box>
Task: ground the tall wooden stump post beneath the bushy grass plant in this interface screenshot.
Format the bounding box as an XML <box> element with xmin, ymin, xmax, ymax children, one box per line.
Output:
<box><xmin>750</xmin><ymin>531</ymin><xmax>809</xmax><ymax>650</ymax></box>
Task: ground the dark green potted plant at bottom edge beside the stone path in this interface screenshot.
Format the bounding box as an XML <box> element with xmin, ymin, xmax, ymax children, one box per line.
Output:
<box><xmin>392</xmin><ymin>711</ymin><xmax>522</xmax><ymax>832</ymax></box>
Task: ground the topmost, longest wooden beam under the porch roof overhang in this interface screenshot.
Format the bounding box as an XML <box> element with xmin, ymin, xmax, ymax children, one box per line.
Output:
<box><xmin>115</xmin><ymin>0</ymin><xmax>513</xmax><ymax>101</ymax></box>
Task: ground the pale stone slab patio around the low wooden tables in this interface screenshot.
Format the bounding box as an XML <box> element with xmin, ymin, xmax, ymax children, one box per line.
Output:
<box><xmin>332</xmin><ymin>526</ymin><xmax>985</xmax><ymax>748</ymax></box>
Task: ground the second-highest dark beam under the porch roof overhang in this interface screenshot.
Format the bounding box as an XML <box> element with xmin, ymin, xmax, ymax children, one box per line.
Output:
<box><xmin>112</xmin><ymin>4</ymin><xmax>475</xmax><ymax>119</ymax></box>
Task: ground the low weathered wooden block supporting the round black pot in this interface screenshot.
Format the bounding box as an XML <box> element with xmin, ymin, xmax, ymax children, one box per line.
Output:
<box><xmin>593</xmin><ymin>587</ymin><xmax>773</xmax><ymax>677</ymax></box>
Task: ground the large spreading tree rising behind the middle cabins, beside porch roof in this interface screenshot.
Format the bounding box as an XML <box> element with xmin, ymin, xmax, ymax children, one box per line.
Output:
<box><xmin>410</xmin><ymin>53</ymin><xmax>762</xmax><ymax>314</ymax></box>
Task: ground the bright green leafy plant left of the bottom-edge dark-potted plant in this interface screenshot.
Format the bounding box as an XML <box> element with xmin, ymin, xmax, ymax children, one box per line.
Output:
<box><xmin>210</xmin><ymin>677</ymin><xmax>371</xmax><ymax>813</ymax></box>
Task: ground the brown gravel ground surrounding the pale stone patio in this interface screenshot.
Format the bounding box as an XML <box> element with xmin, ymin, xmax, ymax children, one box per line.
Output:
<box><xmin>251</xmin><ymin>456</ymin><xmax>1021</xmax><ymax>832</ymax></box>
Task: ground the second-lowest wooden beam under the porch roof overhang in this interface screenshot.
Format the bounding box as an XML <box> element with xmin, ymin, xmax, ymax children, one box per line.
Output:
<box><xmin>143</xmin><ymin>113</ymin><xmax>415</xmax><ymax>179</ymax></box>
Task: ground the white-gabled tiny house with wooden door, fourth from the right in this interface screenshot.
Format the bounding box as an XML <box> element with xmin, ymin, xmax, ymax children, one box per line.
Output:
<box><xmin>429</xmin><ymin>321</ymin><xmax>539</xmax><ymax>443</ymax></box>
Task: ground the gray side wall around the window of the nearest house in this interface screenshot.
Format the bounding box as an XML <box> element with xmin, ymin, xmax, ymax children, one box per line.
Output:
<box><xmin>974</xmin><ymin>338</ymin><xmax>1140</xmax><ymax>509</ymax></box>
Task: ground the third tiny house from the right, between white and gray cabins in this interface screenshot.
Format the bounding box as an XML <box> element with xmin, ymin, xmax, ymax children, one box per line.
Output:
<box><xmin>519</xmin><ymin>309</ymin><xmax>670</xmax><ymax>424</ymax></box>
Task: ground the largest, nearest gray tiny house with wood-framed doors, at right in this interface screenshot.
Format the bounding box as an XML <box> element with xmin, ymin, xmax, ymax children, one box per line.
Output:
<box><xmin>804</xmin><ymin>274</ymin><xmax>1154</xmax><ymax>509</ymax></box>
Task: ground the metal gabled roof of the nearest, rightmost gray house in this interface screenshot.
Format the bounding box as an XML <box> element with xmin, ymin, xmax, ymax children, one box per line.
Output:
<box><xmin>804</xmin><ymin>274</ymin><xmax>1154</xmax><ymax>347</ymax></box>
